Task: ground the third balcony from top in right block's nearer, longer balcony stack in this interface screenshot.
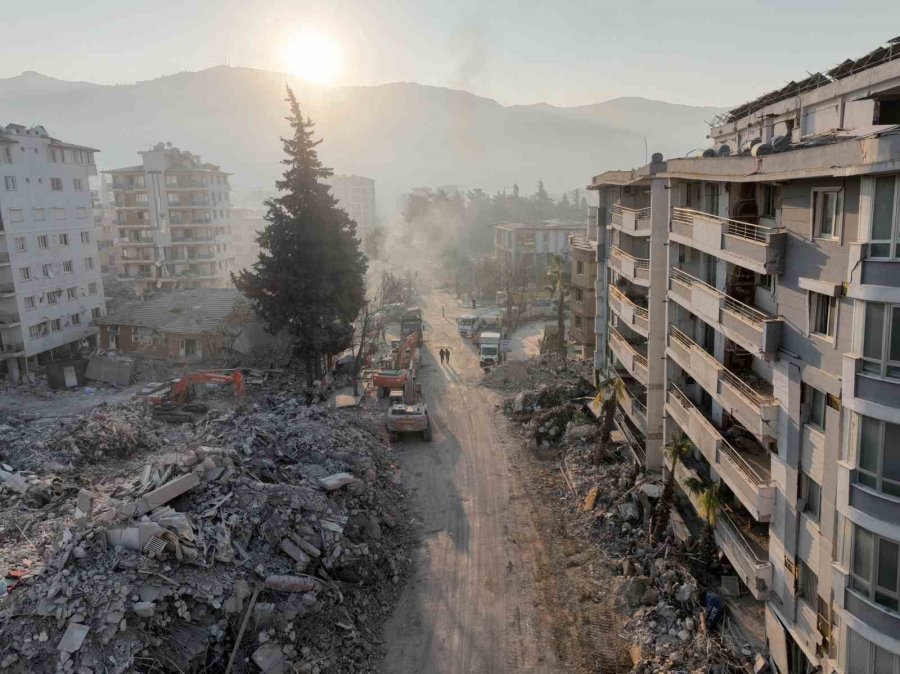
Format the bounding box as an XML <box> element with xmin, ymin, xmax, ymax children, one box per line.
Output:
<box><xmin>666</xmin><ymin>325</ymin><xmax>778</xmax><ymax>445</ymax></box>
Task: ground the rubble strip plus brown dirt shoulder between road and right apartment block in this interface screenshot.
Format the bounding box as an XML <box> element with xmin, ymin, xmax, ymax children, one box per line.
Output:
<box><xmin>493</xmin><ymin>357</ymin><xmax>762</xmax><ymax>674</ymax></box>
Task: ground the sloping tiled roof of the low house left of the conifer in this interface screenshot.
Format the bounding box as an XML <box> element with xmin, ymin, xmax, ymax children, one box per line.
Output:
<box><xmin>95</xmin><ymin>288</ymin><xmax>250</xmax><ymax>335</ymax></box>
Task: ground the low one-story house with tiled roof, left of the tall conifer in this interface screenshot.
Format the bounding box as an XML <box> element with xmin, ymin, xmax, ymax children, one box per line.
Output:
<box><xmin>97</xmin><ymin>288</ymin><xmax>279</xmax><ymax>362</ymax></box>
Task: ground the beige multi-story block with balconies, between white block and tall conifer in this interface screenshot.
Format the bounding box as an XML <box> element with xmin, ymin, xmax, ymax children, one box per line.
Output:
<box><xmin>104</xmin><ymin>143</ymin><xmax>234</xmax><ymax>294</ymax></box>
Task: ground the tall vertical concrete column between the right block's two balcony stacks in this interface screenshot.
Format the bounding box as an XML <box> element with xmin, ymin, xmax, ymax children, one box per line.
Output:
<box><xmin>646</xmin><ymin>178</ymin><xmax>671</xmax><ymax>471</ymax></box>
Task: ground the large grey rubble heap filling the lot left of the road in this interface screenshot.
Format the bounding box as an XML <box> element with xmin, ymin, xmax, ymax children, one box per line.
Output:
<box><xmin>0</xmin><ymin>386</ymin><xmax>412</xmax><ymax>674</ymax></box>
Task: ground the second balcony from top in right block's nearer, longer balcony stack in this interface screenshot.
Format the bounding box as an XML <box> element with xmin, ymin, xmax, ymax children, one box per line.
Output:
<box><xmin>669</xmin><ymin>268</ymin><xmax>783</xmax><ymax>356</ymax></box>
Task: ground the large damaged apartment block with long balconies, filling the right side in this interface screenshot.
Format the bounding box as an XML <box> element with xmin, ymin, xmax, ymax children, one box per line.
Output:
<box><xmin>576</xmin><ymin>38</ymin><xmax>900</xmax><ymax>674</ymax></box>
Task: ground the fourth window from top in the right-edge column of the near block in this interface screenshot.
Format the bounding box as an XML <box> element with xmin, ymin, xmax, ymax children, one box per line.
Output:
<box><xmin>850</xmin><ymin>525</ymin><xmax>900</xmax><ymax>611</ymax></box>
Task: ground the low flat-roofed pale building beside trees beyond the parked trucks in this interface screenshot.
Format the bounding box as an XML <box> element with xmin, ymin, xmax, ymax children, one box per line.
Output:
<box><xmin>494</xmin><ymin>220</ymin><xmax>584</xmax><ymax>283</ymax></box>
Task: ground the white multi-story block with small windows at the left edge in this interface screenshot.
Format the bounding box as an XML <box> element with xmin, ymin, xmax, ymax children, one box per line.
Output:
<box><xmin>0</xmin><ymin>124</ymin><xmax>104</xmax><ymax>382</ymax></box>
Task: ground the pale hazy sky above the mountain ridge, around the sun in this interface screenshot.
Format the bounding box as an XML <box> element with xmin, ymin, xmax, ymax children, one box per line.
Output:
<box><xmin>0</xmin><ymin>0</ymin><xmax>900</xmax><ymax>105</ymax></box>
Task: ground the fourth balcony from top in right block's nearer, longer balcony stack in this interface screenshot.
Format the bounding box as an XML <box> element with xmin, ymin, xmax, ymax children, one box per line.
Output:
<box><xmin>666</xmin><ymin>384</ymin><xmax>775</xmax><ymax>522</ymax></box>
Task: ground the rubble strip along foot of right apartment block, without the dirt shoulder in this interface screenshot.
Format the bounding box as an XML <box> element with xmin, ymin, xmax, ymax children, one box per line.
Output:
<box><xmin>504</xmin><ymin>354</ymin><xmax>753</xmax><ymax>674</ymax></box>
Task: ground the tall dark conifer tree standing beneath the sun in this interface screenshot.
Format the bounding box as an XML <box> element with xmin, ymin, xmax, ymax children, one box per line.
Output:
<box><xmin>232</xmin><ymin>88</ymin><xmax>367</xmax><ymax>384</ymax></box>
